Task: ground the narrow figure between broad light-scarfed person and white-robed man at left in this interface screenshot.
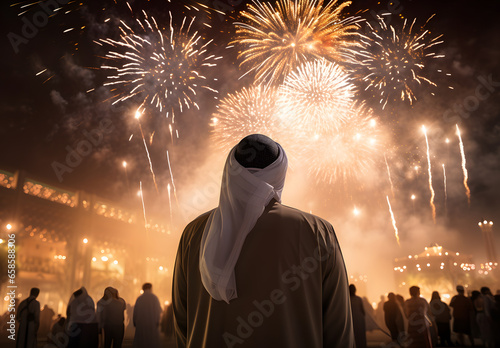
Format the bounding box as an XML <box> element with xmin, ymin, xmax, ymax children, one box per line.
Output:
<box><xmin>97</xmin><ymin>287</ymin><xmax>126</xmax><ymax>348</ymax></box>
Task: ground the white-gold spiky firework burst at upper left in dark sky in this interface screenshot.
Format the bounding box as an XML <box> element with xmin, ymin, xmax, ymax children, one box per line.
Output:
<box><xmin>95</xmin><ymin>11</ymin><xmax>221</xmax><ymax>123</ymax></box>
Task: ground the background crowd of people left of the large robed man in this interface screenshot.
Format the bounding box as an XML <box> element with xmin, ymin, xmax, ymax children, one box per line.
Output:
<box><xmin>2</xmin><ymin>283</ymin><xmax>174</xmax><ymax>348</ymax></box>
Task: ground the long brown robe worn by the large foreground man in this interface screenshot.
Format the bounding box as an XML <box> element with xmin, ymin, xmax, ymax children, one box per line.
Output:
<box><xmin>172</xmin><ymin>200</ymin><xmax>354</xmax><ymax>348</ymax></box>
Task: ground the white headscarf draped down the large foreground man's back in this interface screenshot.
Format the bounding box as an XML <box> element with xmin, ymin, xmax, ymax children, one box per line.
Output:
<box><xmin>200</xmin><ymin>144</ymin><xmax>288</xmax><ymax>303</ymax></box>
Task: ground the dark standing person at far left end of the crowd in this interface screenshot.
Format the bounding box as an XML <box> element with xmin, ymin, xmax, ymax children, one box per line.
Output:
<box><xmin>16</xmin><ymin>288</ymin><xmax>40</xmax><ymax>348</ymax></box>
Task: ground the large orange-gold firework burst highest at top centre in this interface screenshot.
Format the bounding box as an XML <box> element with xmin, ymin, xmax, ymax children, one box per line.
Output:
<box><xmin>231</xmin><ymin>0</ymin><xmax>361</xmax><ymax>83</ymax></box>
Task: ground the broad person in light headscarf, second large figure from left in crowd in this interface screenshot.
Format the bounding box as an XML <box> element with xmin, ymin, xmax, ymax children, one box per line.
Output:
<box><xmin>66</xmin><ymin>286</ymin><xmax>99</xmax><ymax>348</ymax></box>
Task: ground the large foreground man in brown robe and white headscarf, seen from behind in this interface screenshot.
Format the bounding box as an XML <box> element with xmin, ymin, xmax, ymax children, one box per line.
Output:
<box><xmin>172</xmin><ymin>134</ymin><xmax>354</xmax><ymax>348</ymax></box>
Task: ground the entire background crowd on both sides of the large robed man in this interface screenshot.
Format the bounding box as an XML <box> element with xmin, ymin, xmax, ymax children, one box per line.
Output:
<box><xmin>2</xmin><ymin>283</ymin><xmax>500</xmax><ymax>348</ymax></box>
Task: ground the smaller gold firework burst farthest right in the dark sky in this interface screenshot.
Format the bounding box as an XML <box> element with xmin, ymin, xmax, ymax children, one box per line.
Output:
<box><xmin>354</xmin><ymin>16</ymin><xmax>449</xmax><ymax>109</ymax></box>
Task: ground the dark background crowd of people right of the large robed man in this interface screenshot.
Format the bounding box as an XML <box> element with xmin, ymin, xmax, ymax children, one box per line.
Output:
<box><xmin>351</xmin><ymin>285</ymin><xmax>500</xmax><ymax>348</ymax></box>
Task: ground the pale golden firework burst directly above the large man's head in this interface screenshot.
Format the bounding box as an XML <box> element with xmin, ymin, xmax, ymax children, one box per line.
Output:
<box><xmin>211</xmin><ymin>85</ymin><xmax>285</xmax><ymax>152</ymax></box>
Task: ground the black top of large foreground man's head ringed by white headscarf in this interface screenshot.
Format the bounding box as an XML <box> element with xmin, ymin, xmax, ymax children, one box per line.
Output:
<box><xmin>234</xmin><ymin>134</ymin><xmax>280</xmax><ymax>169</ymax></box>
